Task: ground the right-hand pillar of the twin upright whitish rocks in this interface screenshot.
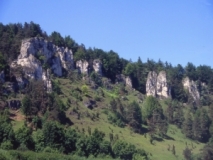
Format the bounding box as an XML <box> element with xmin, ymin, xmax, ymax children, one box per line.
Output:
<box><xmin>157</xmin><ymin>71</ymin><xmax>171</xmax><ymax>98</ymax></box>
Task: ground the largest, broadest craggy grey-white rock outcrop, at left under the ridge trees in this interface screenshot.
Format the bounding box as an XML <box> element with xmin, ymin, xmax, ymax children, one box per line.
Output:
<box><xmin>11</xmin><ymin>38</ymin><xmax>73</xmax><ymax>79</ymax></box>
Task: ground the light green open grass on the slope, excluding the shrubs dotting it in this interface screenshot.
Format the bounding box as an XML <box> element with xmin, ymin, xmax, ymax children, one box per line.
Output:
<box><xmin>7</xmin><ymin>78</ymin><xmax>204</xmax><ymax>160</ymax></box>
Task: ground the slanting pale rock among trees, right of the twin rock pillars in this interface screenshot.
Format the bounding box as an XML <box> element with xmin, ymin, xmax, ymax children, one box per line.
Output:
<box><xmin>182</xmin><ymin>77</ymin><xmax>200</xmax><ymax>101</ymax></box>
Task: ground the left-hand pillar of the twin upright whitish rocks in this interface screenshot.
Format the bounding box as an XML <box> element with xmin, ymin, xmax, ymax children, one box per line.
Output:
<box><xmin>146</xmin><ymin>71</ymin><xmax>157</xmax><ymax>97</ymax></box>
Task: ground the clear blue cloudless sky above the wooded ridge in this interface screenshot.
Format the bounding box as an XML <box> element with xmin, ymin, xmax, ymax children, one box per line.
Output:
<box><xmin>0</xmin><ymin>0</ymin><xmax>213</xmax><ymax>67</ymax></box>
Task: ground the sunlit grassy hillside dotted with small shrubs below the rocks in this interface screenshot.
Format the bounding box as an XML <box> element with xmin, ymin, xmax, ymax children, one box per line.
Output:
<box><xmin>7</xmin><ymin>78</ymin><xmax>204</xmax><ymax>160</ymax></box>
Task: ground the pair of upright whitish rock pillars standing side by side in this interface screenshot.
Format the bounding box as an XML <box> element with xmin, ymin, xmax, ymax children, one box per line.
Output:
<box><xmin>146</xmin><ymin>71</ymin><xmax>171</xmax><ymax>98</ymax></box>
